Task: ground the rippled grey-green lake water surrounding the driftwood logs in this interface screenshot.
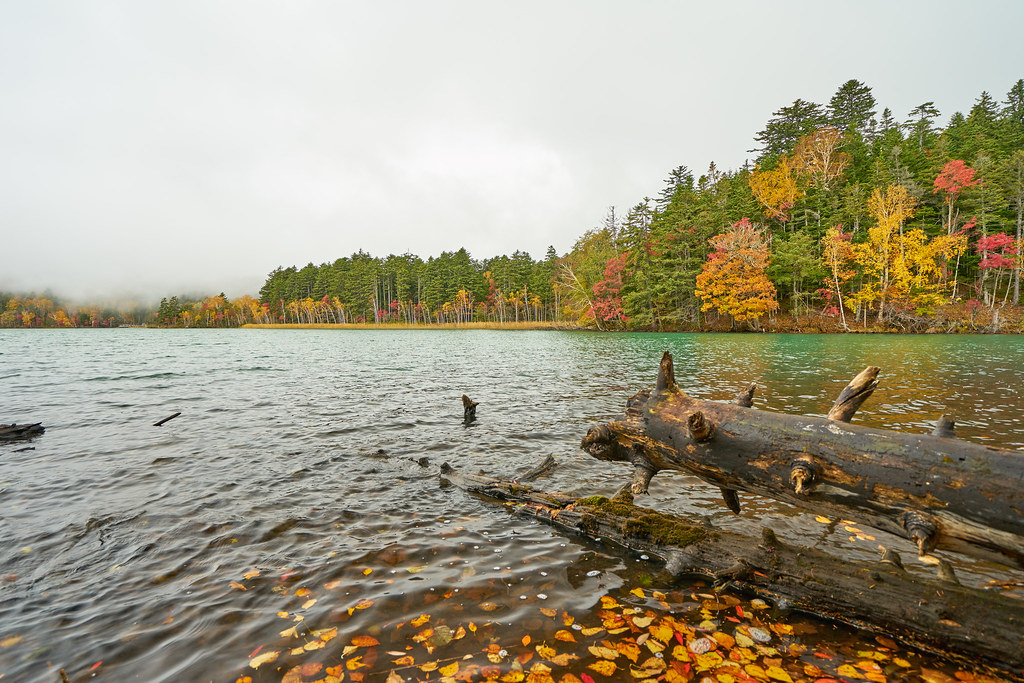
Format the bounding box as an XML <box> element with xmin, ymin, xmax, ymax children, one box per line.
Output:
<box><xmin>0</xmin><ymin>330</ymin><xmax>1024</xmax><ymax>683</ymax></box>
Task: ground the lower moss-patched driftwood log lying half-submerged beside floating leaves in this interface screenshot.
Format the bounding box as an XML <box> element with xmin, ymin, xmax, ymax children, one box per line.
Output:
<box><xmin>441</xmin><ymin>464</ymin><xmax>1024</xmax><ymax>680</ymax></box>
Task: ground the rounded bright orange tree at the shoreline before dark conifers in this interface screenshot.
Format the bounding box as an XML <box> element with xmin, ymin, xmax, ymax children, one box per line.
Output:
<box><xmin>695</xmin><ymin>218</ymin><xmax>778</xmax><ymax>327</ymax></box>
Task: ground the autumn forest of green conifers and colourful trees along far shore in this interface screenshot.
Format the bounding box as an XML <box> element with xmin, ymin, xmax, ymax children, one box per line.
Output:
<box><xmin>0</xmin><ymin>79</ymin><xmax>1024</xmax><ymax>332</ymax></box>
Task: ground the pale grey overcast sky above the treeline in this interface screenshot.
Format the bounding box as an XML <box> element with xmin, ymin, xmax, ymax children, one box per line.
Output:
<box><xmin>0</xmin><ymin>0</ymin><xmax>1024</xmax><ymax>298</ymax></box>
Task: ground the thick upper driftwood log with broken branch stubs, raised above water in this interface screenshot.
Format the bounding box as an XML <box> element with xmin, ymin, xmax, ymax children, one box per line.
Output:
<box><xmin>582</xmin><ymin>353</ymin><xmax>1024</xmax><ymax>567</ymax></box>
